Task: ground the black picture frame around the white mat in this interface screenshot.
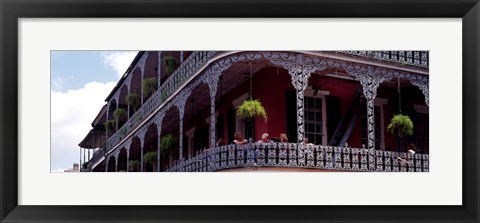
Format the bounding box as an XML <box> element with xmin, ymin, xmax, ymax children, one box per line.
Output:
<box><xmin>0</xmin><ymin>0</ymin><xmax>480</xmax><ymax>222</ymax></box>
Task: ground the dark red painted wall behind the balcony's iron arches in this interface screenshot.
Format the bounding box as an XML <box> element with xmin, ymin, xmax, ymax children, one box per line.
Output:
<box><xmin>182</xmin><ymin>65</ymin><xmax>425</xmax><ymax>152</ymax></box>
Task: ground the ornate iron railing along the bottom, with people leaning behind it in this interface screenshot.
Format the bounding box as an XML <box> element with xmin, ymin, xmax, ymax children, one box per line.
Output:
<box><xmin>166</xmin><ymin>143</ymin><xmax>429</xmax><ymax>172</ymax></box>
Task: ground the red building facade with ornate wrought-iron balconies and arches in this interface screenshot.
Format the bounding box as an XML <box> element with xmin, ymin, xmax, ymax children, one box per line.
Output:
<box><xmin>79</xmin><ymin>51</ymin><xmax>429</xmax><ymax>172</ymax></box>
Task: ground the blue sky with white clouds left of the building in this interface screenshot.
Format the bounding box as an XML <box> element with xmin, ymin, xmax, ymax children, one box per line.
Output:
<box><xmin>50</xmin><ymin>51</ymin><xmax>138</xmax><ymax>172</ymax></box>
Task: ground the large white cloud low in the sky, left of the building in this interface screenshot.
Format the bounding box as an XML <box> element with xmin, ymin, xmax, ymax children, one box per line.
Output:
<box><xmin>51</xmin><ymin>82</ymin><xmax>116</xmax><ymax>171</ymax></box>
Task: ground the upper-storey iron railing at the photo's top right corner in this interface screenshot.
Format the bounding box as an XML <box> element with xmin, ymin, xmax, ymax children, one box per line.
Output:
<box><xmin>339</xmin><ymin>51</ymin><xmax>429</xmax><ymax>68</ymax></box>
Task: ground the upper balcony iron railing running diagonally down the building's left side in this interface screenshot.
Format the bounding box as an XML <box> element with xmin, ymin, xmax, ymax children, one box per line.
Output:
<box><xmin>106</xmin><ymin>51</ymin><xmax>217</xmax><ymax>152</ymax></box>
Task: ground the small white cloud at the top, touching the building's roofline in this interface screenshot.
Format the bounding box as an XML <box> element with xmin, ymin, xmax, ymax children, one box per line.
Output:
<box><xmin>102</xmin><ymin>51</ymin><xmax>138</xmax><ymax>78</ymax></box>
